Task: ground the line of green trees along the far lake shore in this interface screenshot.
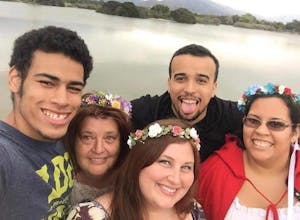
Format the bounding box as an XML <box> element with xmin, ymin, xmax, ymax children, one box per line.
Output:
<box><xmin>7</xmin><ymin>0</ymin><xmax>300</xmax><ymax>34</ymax></box>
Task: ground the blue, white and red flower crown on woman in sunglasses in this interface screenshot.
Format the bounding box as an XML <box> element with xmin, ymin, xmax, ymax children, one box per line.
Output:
<box><xmin>237</xmin><ymin>83</ymin><xmax>300</xmax><ymax>111</ymax></box>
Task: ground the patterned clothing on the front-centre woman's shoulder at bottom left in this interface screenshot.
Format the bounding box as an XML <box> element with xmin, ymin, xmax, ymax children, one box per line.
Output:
<box><xmin>67</xmin><ymin>201</ymin><xmax>108</xmax><ymax>220</ymax></box>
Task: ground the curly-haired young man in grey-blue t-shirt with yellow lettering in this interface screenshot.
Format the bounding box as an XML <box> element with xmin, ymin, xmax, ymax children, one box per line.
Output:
<box><xmin>0</xmin><ymin>26</ymin><xmax>93</xmax><ymax>219</ymax></box>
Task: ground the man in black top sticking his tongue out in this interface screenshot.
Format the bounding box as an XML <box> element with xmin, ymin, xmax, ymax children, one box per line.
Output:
<box><xmin>132</xmin><ymin>44</ymin><xmax>242</xmax><ymax>161</ymax></box>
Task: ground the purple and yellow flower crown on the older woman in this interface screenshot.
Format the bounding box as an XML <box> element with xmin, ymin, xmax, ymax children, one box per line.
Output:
<box><xmin>81</xmin><ymin>91</ymin><xmax>132</xmax><ymax>116</ymax></box>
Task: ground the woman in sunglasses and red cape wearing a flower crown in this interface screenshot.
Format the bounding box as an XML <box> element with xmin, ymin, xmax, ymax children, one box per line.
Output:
<box><xmin>198</xmin><ymin>83</ymin><xmax>300</xmax><ymax>220</ymax></box>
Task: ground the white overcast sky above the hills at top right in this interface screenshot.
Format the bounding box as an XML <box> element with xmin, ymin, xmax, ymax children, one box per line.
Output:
<box><xmin>212</xmin><ymin>0</ymin><xmax>300</xmax><ymax>17</ymax></box>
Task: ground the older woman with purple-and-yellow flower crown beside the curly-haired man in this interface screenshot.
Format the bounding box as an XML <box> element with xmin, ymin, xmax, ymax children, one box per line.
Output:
<box><xmin>64</xmin><ymin>92</ymin><xmax>131</xmax><ymax>205</ymax></box>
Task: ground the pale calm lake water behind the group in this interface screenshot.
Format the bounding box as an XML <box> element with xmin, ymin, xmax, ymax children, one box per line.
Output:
<box><xmin>0</xmin><ymin>1</ymin><xmax>300</xmax><ymax>118</ymax></box>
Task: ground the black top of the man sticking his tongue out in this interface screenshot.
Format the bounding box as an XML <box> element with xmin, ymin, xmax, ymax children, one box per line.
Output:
<box><xmin>131</xmin><ymin>92</ymin><xmax>243</xmax><ymax>161</ymax></box>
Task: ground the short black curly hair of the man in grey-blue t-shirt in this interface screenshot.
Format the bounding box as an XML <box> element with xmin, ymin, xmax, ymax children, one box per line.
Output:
<box><xmin>9</xmin><ymin>26</ymin><xmax>93</xmax><ymax>84</ymax></box>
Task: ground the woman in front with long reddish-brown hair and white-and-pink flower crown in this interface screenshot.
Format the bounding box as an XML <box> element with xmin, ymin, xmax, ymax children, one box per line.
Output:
<box><xmin>67</xmin><ymin>119</ymin><xmax>205</xmax><ymax>220</ymax></box>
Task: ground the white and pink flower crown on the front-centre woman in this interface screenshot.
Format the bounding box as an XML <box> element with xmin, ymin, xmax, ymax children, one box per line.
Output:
<box><xmin>127</xmin><ymin>123</ymin><xmax>200</xmax><ymax>151</ymax></box>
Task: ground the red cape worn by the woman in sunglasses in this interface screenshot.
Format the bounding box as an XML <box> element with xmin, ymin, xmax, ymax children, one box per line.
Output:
<box><xmin>198</xmin><ymin>135</ymin><xmax>300</xmax><ymax>220</ymax></box>
